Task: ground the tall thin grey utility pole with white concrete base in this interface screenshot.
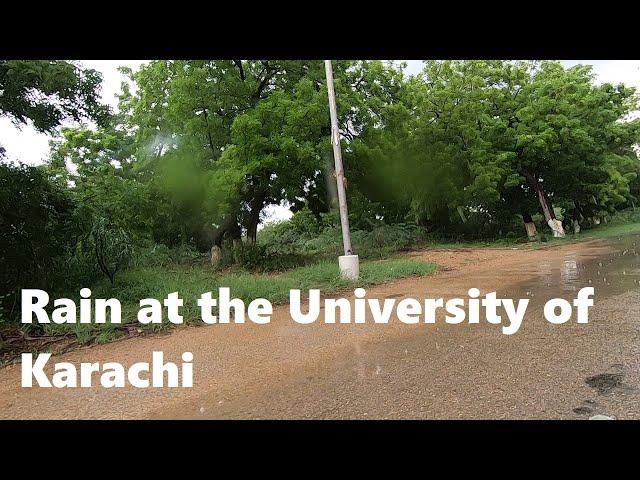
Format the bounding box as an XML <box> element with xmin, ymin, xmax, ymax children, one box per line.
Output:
<box><xmin>324</xmin><ymin>60</ymin><xmax>360</xmax><ymax>280</ymax></box>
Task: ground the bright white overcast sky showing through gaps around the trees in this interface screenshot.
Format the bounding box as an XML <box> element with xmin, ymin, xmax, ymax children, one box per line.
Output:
<box><xmin>0</xmin><ymin>60</ymin><xmax>640</xmax><ymax>220</ymax></box>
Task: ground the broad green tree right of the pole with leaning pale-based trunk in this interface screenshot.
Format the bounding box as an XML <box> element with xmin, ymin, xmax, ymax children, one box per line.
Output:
<box><xmin>358</xmin><ymin>61</ymin><xmax>639</xmax><ymax>234</ymax></box>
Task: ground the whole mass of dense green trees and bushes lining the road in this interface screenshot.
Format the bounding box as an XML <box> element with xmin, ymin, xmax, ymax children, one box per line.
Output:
<box><xmin>0</xmin><ymin>60</ymin><xmax>640</xmax><ymax>334</ymax></box>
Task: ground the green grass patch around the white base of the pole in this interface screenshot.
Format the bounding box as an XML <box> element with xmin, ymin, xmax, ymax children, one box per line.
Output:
<box><xmin>45</xmin><ymin>258</ymin><xmax>436</xmax><ymax>343</ymax></box>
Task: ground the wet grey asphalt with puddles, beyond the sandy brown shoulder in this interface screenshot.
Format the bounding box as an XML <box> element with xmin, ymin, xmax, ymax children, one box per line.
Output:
<box><xmin>190</xmin><ymin>235</ymin><xmax>640</xmax><ymax>418</ymax></box>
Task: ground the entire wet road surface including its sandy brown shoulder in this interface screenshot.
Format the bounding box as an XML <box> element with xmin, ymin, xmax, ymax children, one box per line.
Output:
<box><xmin>0</xmin><ymin>236</ymin><xmax>640</xmax><ymax>419</ymax></box>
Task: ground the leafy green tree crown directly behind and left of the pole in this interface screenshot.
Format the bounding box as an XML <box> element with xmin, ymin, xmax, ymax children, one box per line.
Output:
<box><xmin>125</xmin><ymin>60</ymin><xmax>401</xmax><ymax>253</ymax></box>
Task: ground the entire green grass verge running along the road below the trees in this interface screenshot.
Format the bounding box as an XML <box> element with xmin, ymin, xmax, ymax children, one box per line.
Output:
<box><xmin>12</xmin><ymin>209</ymin><xmax>640</xmax><ymax>350</ymax></box>
